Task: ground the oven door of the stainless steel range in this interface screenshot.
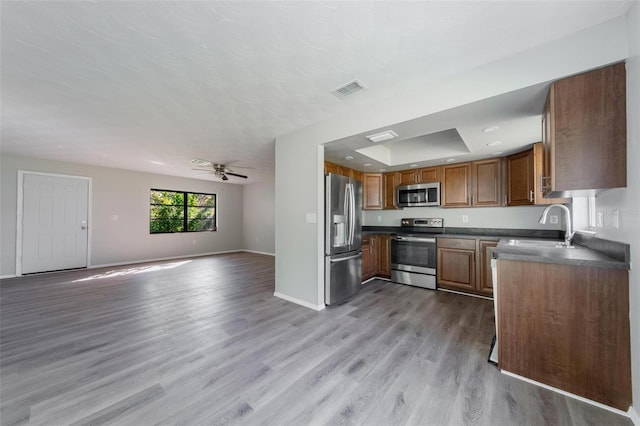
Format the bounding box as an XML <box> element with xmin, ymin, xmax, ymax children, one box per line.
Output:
<box><xmin>391</xmin><ymin>235</ymin><xmax>436</xmax><ymax>274</ymax></box>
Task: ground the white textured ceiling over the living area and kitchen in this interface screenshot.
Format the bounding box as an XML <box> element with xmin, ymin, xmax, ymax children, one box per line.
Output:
<box><xmin>0</xmin><ymin>1</ymin><xmax>631</xmax><ymax>183</ymax></box>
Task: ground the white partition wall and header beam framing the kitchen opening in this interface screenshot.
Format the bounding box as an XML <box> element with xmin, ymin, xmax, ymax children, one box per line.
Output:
<box><xmin>276</xmin><ymin>18</ymin><xmax>627</xmax><ymax>306</ymax></box>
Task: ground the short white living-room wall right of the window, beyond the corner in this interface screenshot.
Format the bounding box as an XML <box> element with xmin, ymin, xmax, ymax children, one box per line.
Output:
<box><xmin>242</xmin><ymin>180</ymin><xmax>276</xmax><ymax>254</ymax></box>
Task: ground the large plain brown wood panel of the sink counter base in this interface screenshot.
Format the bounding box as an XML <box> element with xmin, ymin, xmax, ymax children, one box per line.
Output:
<box><xmin>497</xmin><ymin>259</ymin><xmax>631</xmax><ymax>411</ymax></box>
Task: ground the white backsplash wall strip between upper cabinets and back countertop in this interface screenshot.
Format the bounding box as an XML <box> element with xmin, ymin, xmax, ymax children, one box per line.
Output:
<box><xmin>363</xmin><ymin>206</ymin><xmax>564</xmax><ymax>230</ymax></box>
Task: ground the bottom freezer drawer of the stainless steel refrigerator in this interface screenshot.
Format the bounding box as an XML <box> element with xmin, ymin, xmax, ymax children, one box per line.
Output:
<box><xmin>324</xmin><ymin>252</ymin><xmax>362</xmax><ymax>305</ymax></box>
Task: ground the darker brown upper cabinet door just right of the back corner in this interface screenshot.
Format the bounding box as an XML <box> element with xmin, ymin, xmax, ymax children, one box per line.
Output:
<box><xmin>507</xmin><ymin>149</ymin><xmax>534</xmax><ymax>206</ymax></box>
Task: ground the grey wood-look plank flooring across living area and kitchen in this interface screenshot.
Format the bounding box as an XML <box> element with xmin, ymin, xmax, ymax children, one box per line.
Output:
<box><xmin>0</xmin><ymin>253</ymin><xmax>631</xmax><ymax>425</ymax></box>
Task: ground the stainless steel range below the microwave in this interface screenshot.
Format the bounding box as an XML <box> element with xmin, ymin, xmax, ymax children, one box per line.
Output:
<box><xmin>391</xmin><ymin>218</ymin><xmax>443</xmax><ymax>290</ymax></box>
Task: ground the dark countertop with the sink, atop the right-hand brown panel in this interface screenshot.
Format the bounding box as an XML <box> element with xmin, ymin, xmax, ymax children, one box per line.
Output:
<box><xmin>493</xmin><ymin>238</ymin><xmax>630</xmax><ymax>270</ymax></box>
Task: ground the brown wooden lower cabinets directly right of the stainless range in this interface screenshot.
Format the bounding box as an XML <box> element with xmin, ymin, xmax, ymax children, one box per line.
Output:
<box><xmin>436</xmin><ymin>238</ymin><xmax>498</xmax><ymax>297</ymax></box>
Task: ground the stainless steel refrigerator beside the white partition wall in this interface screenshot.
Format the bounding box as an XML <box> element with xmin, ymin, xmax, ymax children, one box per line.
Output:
<box><xmin>324</xmin><ymin>173</ymin><xmax>362</xmax><ymax>305</ymax></box>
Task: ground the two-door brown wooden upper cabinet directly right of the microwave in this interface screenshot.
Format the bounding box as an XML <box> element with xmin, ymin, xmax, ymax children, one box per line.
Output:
<box><xmin>440</xmin><ymin>158</ymin><xmax>502</xmax><ymax>207</ymax></box>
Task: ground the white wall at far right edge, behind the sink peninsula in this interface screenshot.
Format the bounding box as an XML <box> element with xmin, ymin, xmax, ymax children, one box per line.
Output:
<box><xmin>593</xmin><ymin>2</ymin><xmax>640</xmax><ymax>416</ymax></box>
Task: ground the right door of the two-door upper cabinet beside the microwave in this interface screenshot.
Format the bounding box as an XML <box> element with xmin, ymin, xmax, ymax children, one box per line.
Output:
<box><xmin>471</xmin><ymin>158</ymin><xmax>502</xmax><ymax>207</ymax></box>
